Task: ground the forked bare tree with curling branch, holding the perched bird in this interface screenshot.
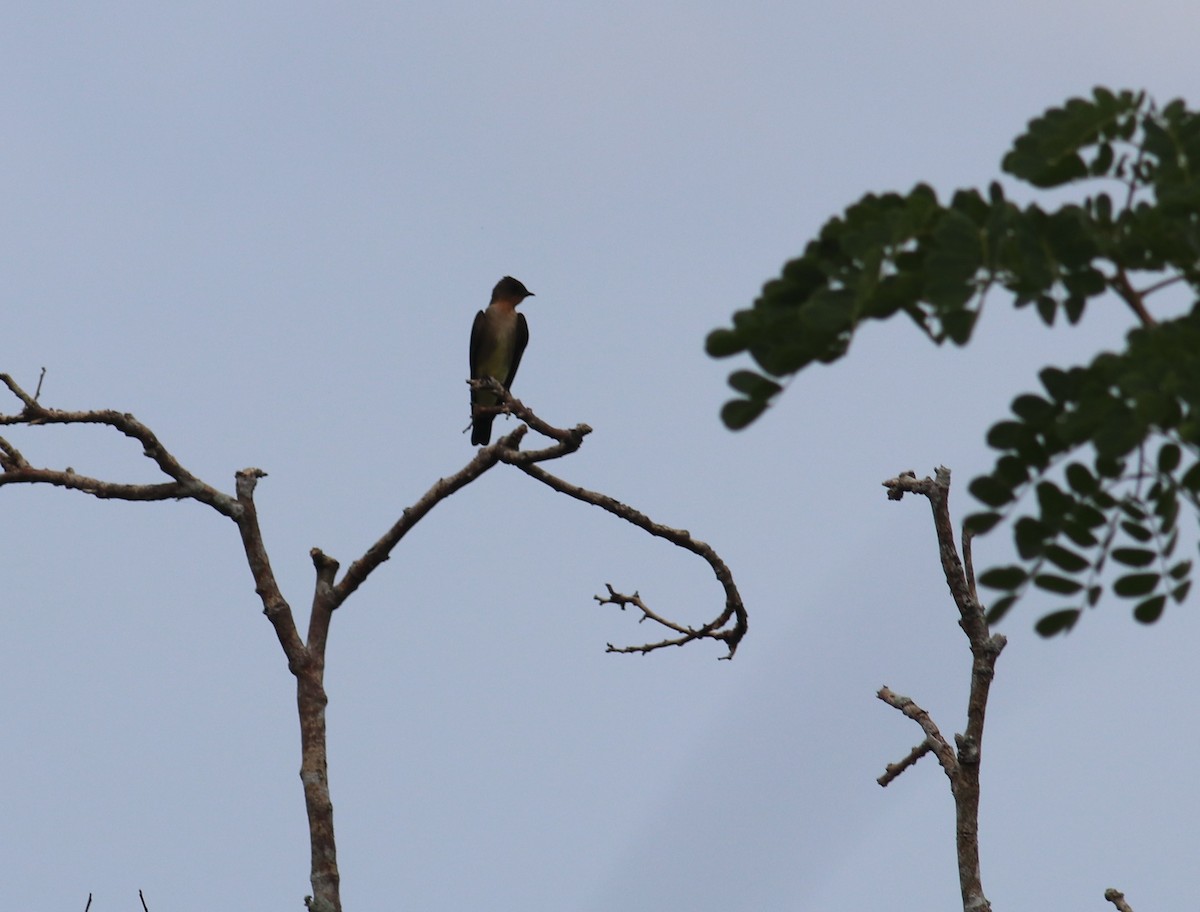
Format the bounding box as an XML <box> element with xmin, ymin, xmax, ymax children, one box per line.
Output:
<box><xmin>0</xmin><ymin>371</ymin><xmax>746</xmax><ymax>912</ymax></box>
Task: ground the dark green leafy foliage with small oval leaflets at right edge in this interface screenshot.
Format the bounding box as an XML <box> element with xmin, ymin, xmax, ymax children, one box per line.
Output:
<box><xmin>707</xmin><ymin>88</ymin><xmax>1200</xmax><ymax>635</ymax></box>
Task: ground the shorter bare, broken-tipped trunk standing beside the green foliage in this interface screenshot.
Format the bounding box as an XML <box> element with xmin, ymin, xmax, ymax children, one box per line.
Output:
<box><xmin>876</xmin><ymin>466</ymin><xmax>1133</xmax><ymax>912</ymax></box>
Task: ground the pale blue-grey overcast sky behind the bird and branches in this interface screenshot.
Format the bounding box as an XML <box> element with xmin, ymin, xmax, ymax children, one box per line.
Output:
<box><xmin>0</xmin><ymin>0</ymin><xmax>1200</xmax><ymax>912</ymax></box>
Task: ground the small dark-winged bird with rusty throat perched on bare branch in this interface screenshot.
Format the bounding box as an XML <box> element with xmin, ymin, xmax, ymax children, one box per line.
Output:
<box><xmin>470</xmin><ymin>276</ymin><xmax>533</xmax><ymax>445</ymax></box>
